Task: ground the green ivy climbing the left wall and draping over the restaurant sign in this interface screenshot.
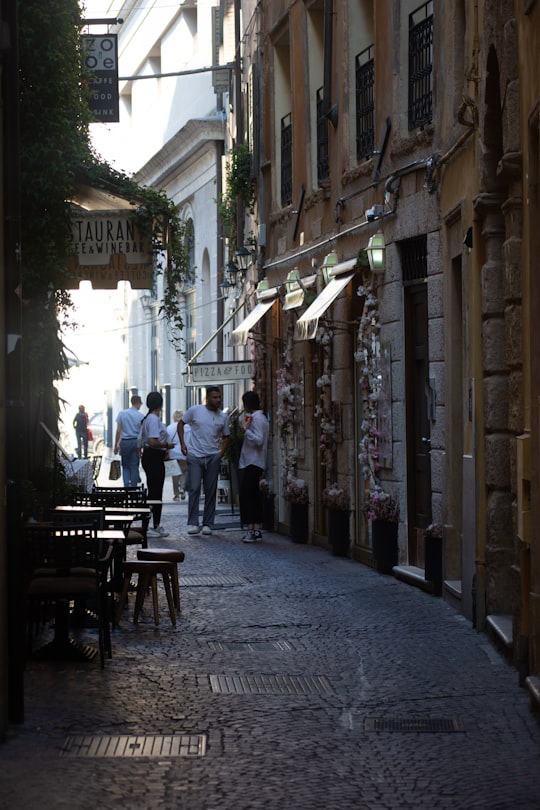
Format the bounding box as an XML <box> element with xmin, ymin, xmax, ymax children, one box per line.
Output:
<box><xmin>18</xmin><ymin>0</ymin><xmax>192</xmax><ymax>480</ymax></box>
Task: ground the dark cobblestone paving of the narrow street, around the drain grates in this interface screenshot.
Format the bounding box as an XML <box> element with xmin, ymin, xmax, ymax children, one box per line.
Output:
<box><xmin>0</xmin><ymin>502</ymin><xmax>540</xmax><ymax>810</ymax></box>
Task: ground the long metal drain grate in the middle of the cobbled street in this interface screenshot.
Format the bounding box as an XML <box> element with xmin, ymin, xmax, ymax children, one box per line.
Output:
<box><xmin>210</xmin><ymin>675</ymin><xmax>332</xmax><ymax>695</ymax></box>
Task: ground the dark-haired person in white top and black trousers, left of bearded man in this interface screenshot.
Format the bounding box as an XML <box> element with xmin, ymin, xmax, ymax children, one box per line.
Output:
<box><xmin>141</xmin><ymin>391</ymin><xmax>173</xmax><ymax>537</ymax></box>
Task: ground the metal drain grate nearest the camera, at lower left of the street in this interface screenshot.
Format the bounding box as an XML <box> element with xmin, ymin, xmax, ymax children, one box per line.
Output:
<box><xmin>61</xmin><ymin>734</ymin><xmax>206</xmax><ymax>758</ymax></box>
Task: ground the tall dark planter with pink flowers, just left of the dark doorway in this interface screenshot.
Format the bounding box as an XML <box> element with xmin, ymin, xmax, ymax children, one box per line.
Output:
<box><xmin>363</xmin><ymin>485</ymin><xmax>399</xmax><ymax>574</ymax></box>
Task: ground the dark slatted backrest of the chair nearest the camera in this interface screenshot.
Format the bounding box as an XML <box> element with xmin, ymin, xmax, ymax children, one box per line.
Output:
<box><xmin>23</xmin><ymin>523</ymin><xmax>101</xmax><ymax>576</ymax></box>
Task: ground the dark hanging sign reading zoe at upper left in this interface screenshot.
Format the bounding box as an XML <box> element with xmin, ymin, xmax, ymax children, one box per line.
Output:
<box><xmin>81</xmin><ymin>34</ymin><xmax>120</xmax><ymax>123</ymax></box>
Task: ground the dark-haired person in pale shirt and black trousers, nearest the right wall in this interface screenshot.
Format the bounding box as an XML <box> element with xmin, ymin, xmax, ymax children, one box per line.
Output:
<box><xmin>238</xmin><ymin>391</ymin><xmax>269</xmax><ymax>543</ymax></box>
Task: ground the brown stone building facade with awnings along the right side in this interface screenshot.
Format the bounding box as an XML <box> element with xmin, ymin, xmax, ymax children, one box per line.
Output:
<box><xmin>231</xmin><ymin>0</ymin><xmax>540</xmax><ymax>696</ymax></box>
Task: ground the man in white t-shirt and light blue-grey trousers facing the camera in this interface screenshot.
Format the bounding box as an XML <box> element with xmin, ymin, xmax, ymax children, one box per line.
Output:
<box><xmin>178</xmin><ymin>385</ymin><xmax>229</xmax><ymax>534</ymax></box>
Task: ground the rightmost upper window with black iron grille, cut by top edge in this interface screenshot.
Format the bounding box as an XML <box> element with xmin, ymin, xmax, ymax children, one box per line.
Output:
<box><xmin>409</xmin><ymin>0</ymin><xmax>433</xmax><ymax>129</ymax></box>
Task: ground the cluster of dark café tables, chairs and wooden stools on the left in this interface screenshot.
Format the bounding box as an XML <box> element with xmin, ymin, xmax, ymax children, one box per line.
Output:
<box><xmin>23</xmin><ymin>486</ymin><xmax>184</xmax><ymax>667</ymax></box>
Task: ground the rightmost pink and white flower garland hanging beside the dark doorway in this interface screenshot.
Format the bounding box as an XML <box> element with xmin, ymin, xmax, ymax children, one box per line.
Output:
<box><xmin>354</xmin><ymin>274</ymin><xmax>381</xmax><ymax>486</ymax></box>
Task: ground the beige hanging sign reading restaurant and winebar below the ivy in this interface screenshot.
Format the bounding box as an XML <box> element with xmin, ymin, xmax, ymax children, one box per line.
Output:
<box><xmin>70</xmin><ymin>211</ymin><xmax>153</xmax><ymax>290</ymax></box>
